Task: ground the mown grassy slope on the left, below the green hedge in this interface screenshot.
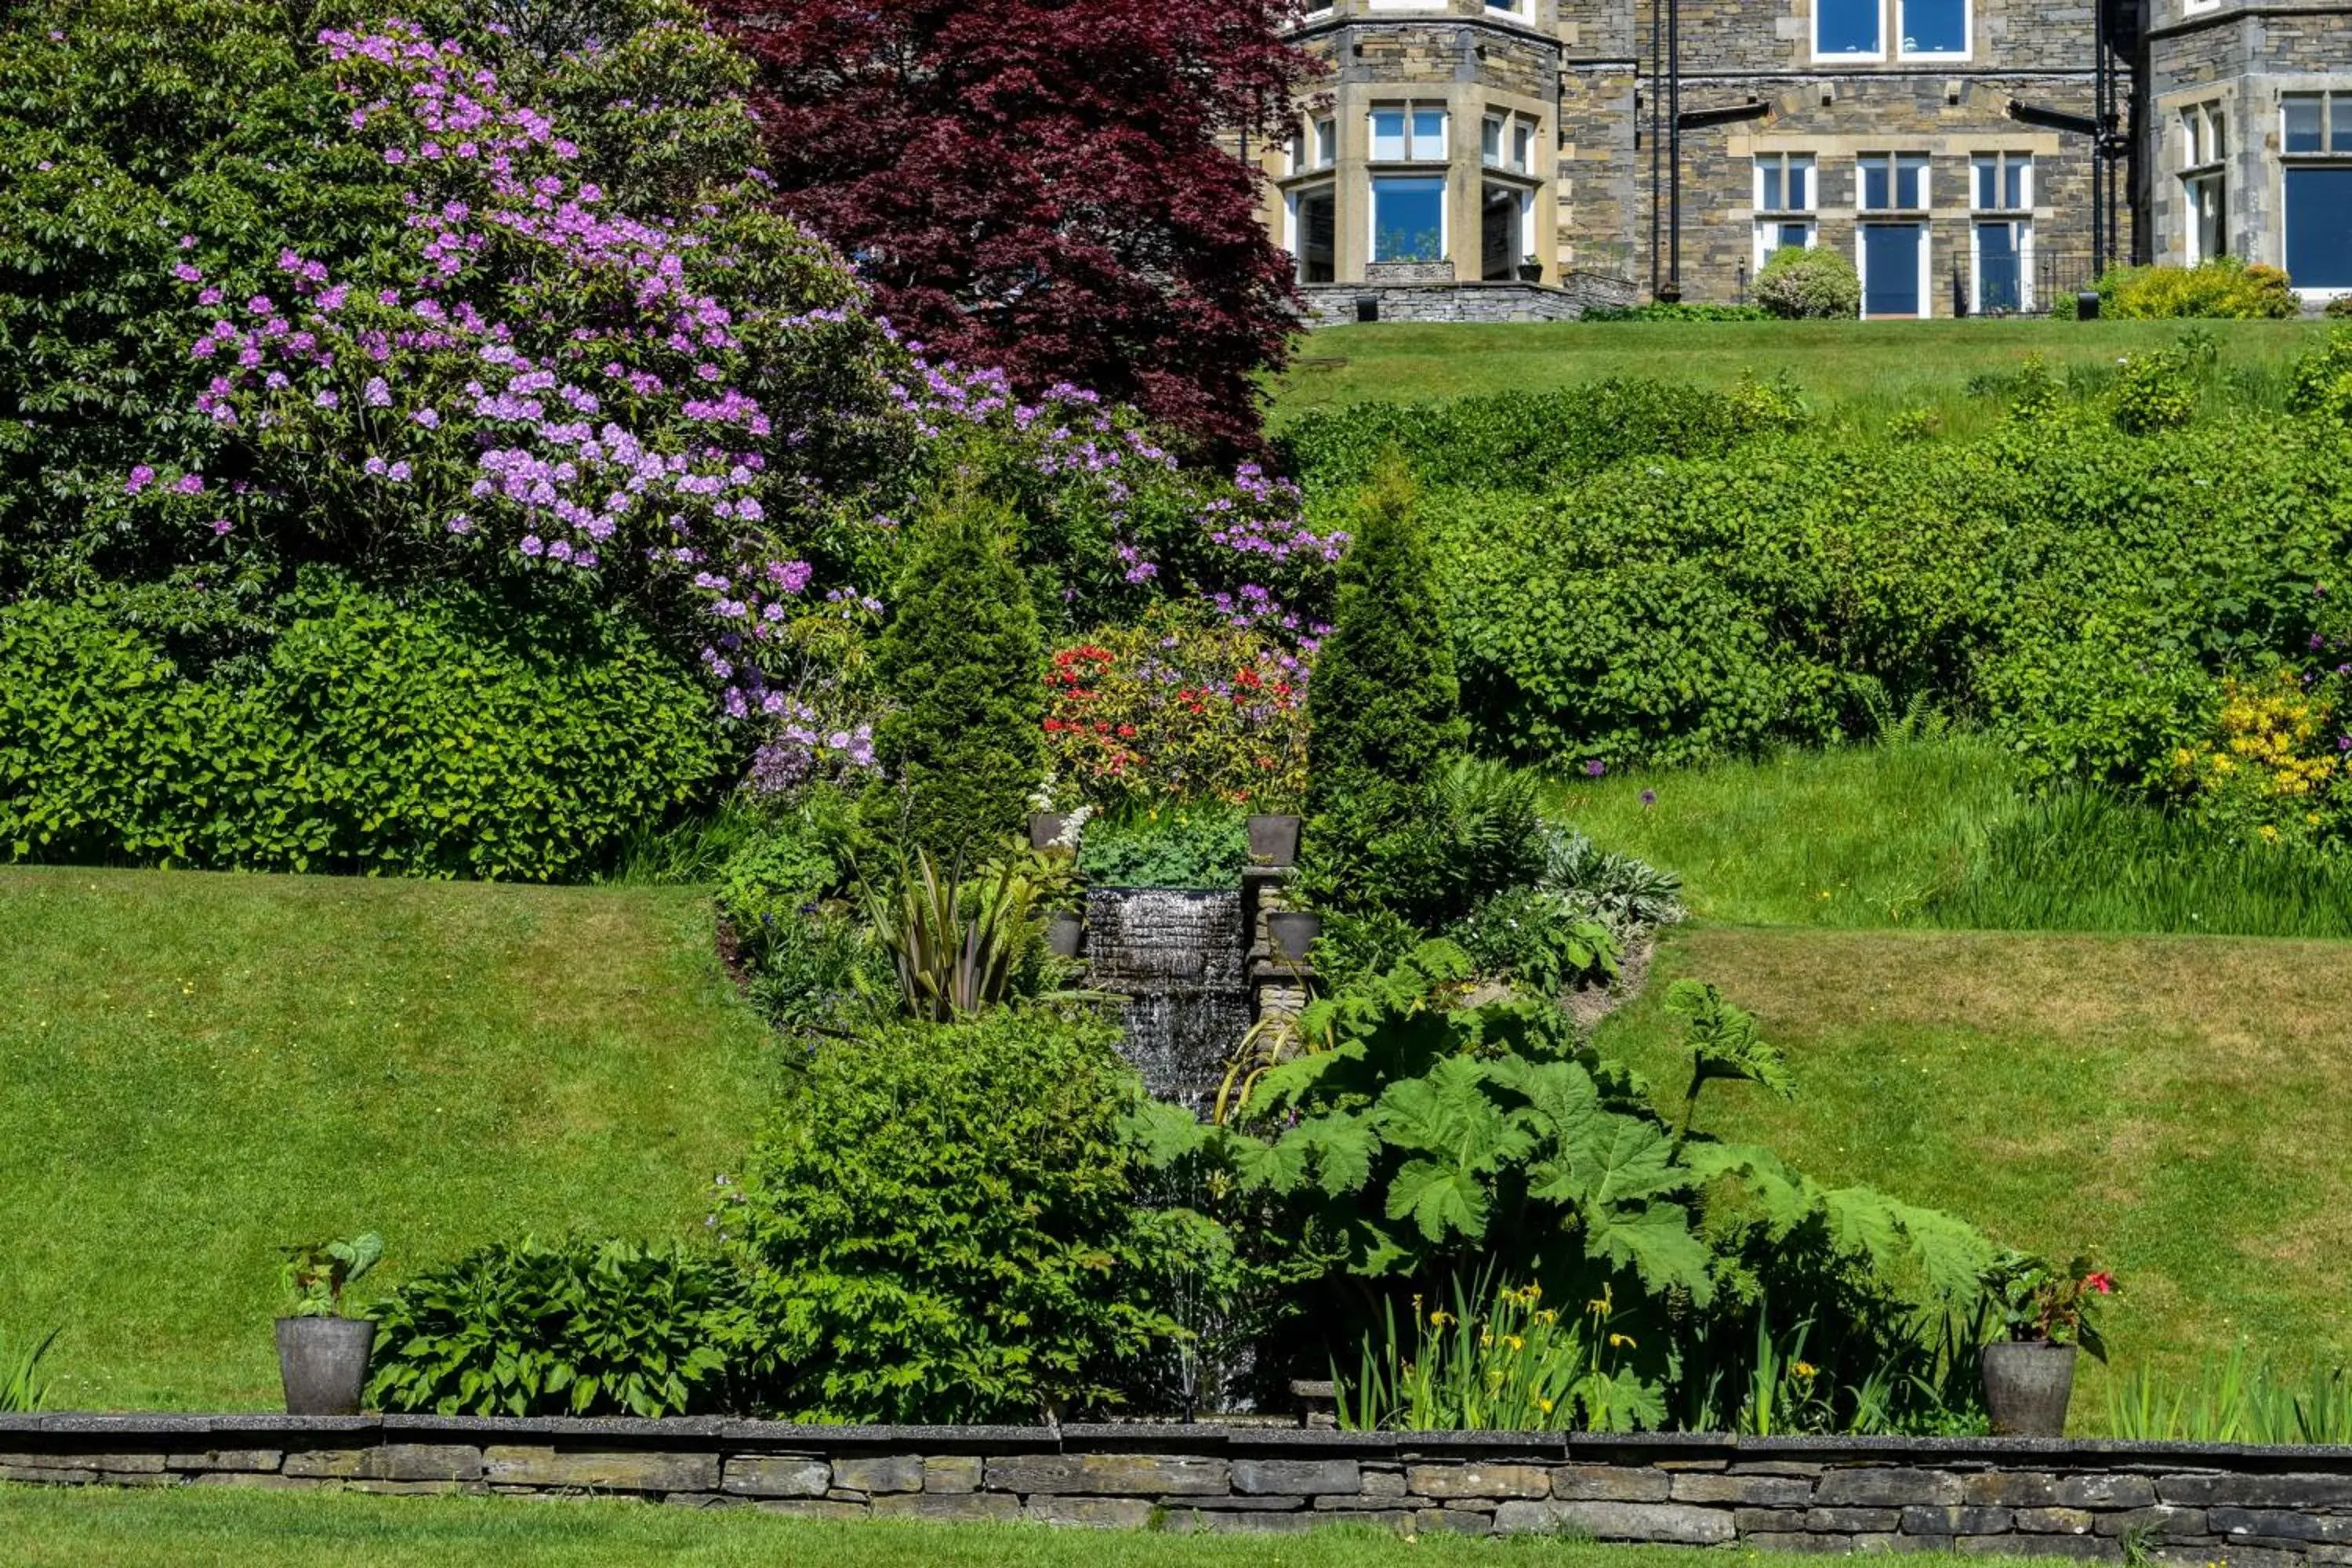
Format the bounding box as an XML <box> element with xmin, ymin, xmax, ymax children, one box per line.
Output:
<box><xmin>0</xmin><ymin>869</ymin><xmax>764</xmax><ymax>1408</ymax></box>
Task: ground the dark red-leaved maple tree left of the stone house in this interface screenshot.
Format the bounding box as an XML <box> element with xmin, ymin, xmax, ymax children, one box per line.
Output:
<box><xmin>703</xmin><ymin>0</ymin><xmax>1317</xmax><ymax>454</ymax></box>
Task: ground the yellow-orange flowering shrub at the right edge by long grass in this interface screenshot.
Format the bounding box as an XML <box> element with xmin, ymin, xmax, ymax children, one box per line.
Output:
<box><xmin>2171</xmin><ymin>666</ymin><xmax>2352</xmax><ymax>844</ymax></box>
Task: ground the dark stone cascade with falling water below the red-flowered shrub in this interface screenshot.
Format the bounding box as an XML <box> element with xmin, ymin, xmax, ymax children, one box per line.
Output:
<box><xmin>1087</xmin><ymin>888</ymin><xmax>1251</xmax><ymax>1116</ymax></box>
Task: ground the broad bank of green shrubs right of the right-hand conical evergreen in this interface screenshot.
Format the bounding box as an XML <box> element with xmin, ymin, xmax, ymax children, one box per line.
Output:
<box><xmin>1430</xmin><ymin>414</ymin><xmax>2352</xmax><ymax>783</ymax></box>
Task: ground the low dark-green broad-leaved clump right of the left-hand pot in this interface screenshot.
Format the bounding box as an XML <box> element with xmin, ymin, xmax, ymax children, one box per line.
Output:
<box><xmin>367</xmin><ymin>1236</ymin><xmax>741</xmax><ymax>1417</ymax></box>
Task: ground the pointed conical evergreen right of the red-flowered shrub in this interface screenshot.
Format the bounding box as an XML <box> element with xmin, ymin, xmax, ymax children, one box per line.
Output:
<box><xmin>1305</xmin><ymin>459</ymin><xmax>1470</xmax><ymax>919</ymax></box>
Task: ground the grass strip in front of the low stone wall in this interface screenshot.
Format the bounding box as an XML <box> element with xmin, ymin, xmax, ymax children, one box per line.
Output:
<box><xmin>0</xmin><ymin>1486</ymin><xmax>2060</xmax><ymax>1568</ymax></box>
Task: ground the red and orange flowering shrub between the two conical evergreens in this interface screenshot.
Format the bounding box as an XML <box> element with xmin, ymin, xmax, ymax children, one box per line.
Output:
<box><xmin>1044</xmin><ymin>604</ymin><xmax>1308</xmax><ymax>811</ymax></box>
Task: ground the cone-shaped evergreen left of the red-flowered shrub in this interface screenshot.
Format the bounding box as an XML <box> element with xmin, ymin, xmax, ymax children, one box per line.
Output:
<box><xmin>868</xmin><ymin>494</ymin><xmax>1044</xmax><ymax>865</ymax></box>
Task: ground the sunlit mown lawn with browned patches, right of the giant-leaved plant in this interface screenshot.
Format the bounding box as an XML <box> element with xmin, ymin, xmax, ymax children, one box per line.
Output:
<box><xmin>1602</xmin><ymin>926</ymin><xmax>2352</xmax><ymax>1432</ymax></box>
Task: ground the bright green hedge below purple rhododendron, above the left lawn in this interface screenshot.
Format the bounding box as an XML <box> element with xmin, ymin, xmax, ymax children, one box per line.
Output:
<box><xmin>0</xmin><ymin>595</ymin><xmax>724</xmax><ymax>879</ymax></box>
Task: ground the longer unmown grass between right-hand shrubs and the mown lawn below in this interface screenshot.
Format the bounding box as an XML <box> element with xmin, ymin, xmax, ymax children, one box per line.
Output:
<box><xmin>1552</xmin><ymin>736</ymin><xmax>2352</xmax><ymax>938</ymax></box>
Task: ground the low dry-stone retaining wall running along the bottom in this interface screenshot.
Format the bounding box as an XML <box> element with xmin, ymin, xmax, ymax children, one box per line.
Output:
<box><xmin>0</xmin><ymin>1415</ymin><xmax>2352</xmax><ymax>1568</ymax></box>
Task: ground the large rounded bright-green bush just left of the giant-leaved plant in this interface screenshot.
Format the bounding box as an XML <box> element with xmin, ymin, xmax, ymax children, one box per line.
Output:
<box><xmin>729</xmin><ymin>1008</ymin><xmax>1176</xmax><ymax>1422</ymax></box>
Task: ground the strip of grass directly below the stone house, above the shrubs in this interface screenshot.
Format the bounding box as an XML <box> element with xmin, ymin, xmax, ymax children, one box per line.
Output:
<box><xmin>1270</xmin><ymin>320</ymin><xmax>2324</xmax><ymax>433</ymax></box>
